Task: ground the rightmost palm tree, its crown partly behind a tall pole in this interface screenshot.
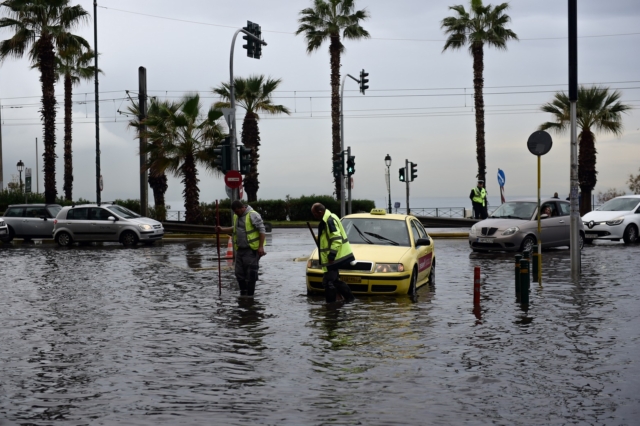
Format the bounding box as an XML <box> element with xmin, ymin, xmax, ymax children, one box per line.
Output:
<box><xmin>539</xmin><ymin>86</ymin><xmax>631</xmax><ymax>216</ymax></box>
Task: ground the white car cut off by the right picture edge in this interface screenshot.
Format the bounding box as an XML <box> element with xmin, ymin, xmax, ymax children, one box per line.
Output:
<box><xmin>582</xmin><ymin>195</ymin><xmax>640</xmax><ymax>244</ymax></box>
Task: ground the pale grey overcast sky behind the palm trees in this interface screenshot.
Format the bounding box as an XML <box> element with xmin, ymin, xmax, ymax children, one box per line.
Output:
<box><xmin>0</xmin><ymin>0</ymin><xmax>640</xmax><ymax>210</ymax></box>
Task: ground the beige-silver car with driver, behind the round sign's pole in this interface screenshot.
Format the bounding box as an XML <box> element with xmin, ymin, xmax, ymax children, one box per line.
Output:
<box><xmin>469</xmin><ymin>198</ymin><xmax>584</xmax><ymax>252</ymax></box>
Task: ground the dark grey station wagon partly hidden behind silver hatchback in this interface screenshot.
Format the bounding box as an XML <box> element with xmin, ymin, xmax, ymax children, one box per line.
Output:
<box><xmin>2</xmin><ymin>204</ymin><xmax>62</xmax><ymax>242</ymax></box>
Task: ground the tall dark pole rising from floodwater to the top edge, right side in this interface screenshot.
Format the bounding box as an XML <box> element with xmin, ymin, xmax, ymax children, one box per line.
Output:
<box><xmin>569</xmin><ymin>0</ymin><xmax>581</xmax><ymax>280</ymax></box>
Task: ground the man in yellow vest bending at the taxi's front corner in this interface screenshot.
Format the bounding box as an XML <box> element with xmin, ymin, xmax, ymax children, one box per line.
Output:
<box><xmin>311</xmin><ymin>203</ymin><xmax>356</xmax><ymax>303</ymax></box>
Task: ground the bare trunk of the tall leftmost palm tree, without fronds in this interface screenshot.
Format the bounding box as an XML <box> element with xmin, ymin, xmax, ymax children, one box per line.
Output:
<box><xmin>37</xmin><ymin>34</ymin><xmax>58</xmax><ymax>204</ymax></box>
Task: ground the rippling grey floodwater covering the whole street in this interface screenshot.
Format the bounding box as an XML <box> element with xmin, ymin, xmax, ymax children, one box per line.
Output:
<box><xmin>0</xmin><ymin>229</ymin><xmax>640</xmax><ymax>425</ymax></box>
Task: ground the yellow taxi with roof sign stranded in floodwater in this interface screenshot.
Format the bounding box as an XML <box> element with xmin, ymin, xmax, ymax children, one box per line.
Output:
<box><xmin>307</xmin><ymin>209</ymin><xmax>436</xmax><ymax>295</ymax></box>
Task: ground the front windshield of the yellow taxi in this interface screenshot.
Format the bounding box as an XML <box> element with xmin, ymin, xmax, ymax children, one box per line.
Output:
<box><xmin>342</xmin><ymin>218</ymin><xmax>411</xmax><ymax>247</ymax></box>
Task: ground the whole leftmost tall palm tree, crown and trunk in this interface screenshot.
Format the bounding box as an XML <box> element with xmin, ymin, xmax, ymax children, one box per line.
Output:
<box><xmin>0</xmin><ymin>0</ymin><xmax>89</xmax><ymax>203</ymax></box>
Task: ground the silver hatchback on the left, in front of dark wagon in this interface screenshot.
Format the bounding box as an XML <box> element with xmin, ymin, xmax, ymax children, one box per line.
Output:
<box><xmin>53</xmin><ymin>204</ymin><xmax>164</xmax><ymax>246</ymax></box>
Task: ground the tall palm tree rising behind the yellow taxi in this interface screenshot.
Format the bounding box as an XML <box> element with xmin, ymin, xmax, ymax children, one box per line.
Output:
<box><xmin>296</xmin><ymin>0</ymin><xmax>371</xmax><ymax>200</ymax></box>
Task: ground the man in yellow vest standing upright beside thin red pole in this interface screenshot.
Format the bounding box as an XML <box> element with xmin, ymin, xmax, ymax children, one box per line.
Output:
<box><xmin>217</xmin><ymin>200</ymin><xmax>267</xmax><ymax>297</ymax></box>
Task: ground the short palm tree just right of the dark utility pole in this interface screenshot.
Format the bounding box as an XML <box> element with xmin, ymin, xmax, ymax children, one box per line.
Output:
<box><xmin>127</xmin><ymin>98</ymin><xmax>172</xmax><ymax>222</ymax></box>
